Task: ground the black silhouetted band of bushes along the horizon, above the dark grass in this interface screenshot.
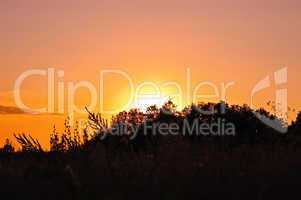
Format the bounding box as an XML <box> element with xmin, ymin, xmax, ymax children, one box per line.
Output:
<box><xmin>0</xmin><ymin>101</ymin><xmax>301</xmax><ymax>153</ymax></box>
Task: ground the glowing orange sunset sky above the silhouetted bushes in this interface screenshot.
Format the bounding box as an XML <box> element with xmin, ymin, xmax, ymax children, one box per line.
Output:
<box><xmin>0</xmin><ymin>0</ymin><xmax>301</xmax><ymax>147</ymax></box>
